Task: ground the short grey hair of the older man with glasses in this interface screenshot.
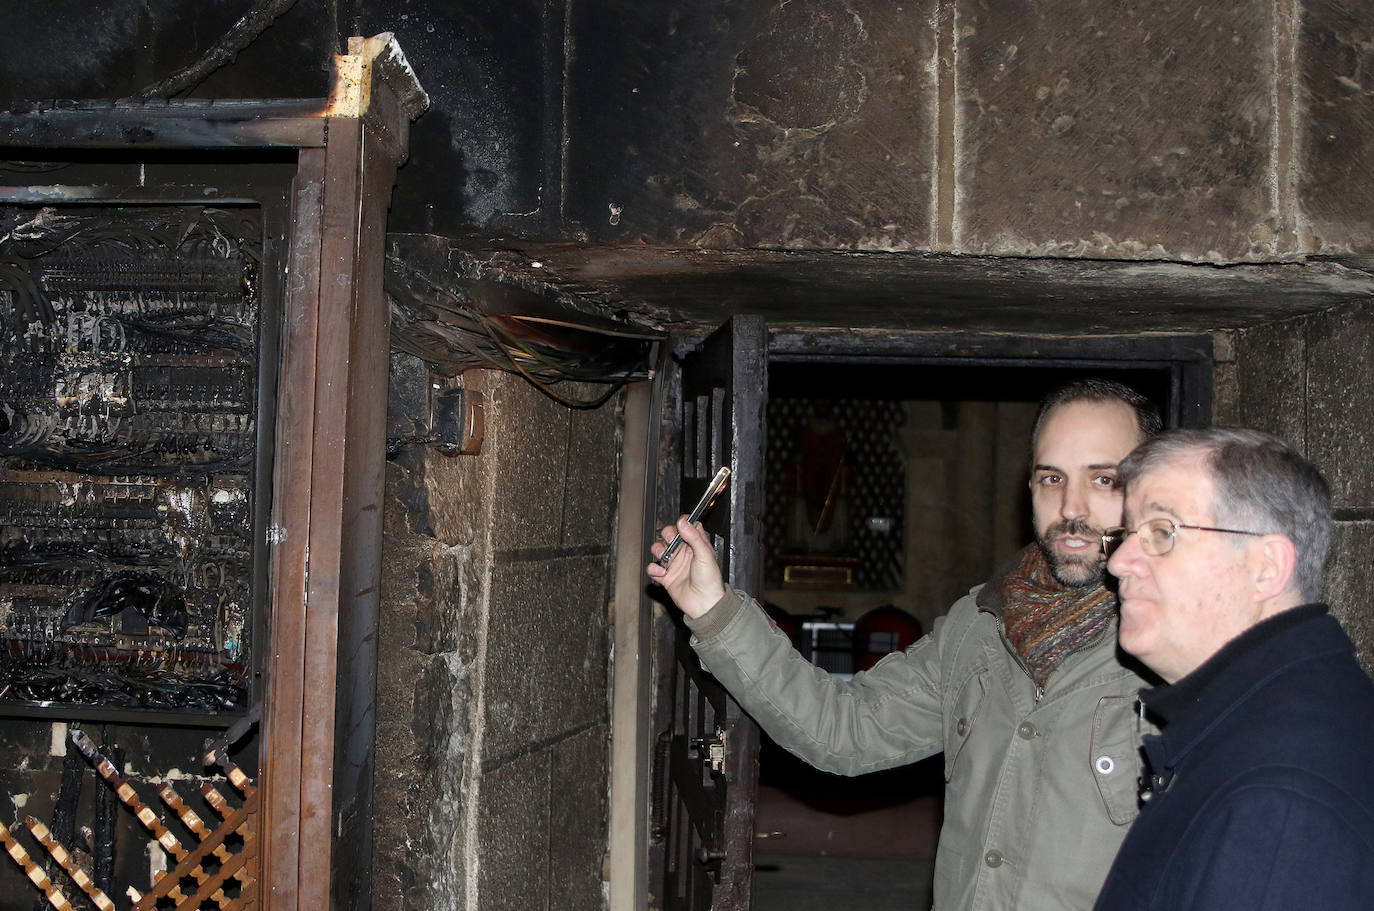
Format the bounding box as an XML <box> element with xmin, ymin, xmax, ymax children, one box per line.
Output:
<box><xmin>1117</xmin><ymin>427</ymin><xmax>1331</xmax><ymax>600</ymax></box>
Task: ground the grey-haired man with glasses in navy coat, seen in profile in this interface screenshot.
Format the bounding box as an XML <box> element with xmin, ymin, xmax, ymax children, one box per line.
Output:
<box><xmin>1098</xmin><ymin>427</ymin><xmax>1374</xmax><ymax>911</ymax></box>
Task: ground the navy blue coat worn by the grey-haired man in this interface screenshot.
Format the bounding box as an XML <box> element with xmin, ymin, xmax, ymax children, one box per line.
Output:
<box><xmin>1096</xmin><ymin>605</ymin><xmax>1374</xmax><ymax>911</ymax></box>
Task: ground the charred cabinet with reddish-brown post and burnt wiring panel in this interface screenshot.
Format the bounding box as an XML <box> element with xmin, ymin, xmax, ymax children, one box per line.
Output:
<box><xmin>0</xmin><ymin>36</ymin><xmax>427</xmax><ymax>911</ymax></box>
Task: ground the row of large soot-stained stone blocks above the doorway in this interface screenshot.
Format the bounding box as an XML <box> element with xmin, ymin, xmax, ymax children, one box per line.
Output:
<box><xmin>563</xmin><ymin>0</ymin><xmax>1374</xmax><ymax>262</ymax></box>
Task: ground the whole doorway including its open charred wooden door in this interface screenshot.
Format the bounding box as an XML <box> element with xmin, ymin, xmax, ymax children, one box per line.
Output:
<box><xmin>637</xmin><ymin>322</ymin><xmax>1212</xmax><ymax>911</ymax></box>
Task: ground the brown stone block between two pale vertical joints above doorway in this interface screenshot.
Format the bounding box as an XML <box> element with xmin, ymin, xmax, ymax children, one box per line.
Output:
<box><xmin>951</xmin><ymin>0</ymin><xmax>1281</xmax><ymax>260</ymax></box>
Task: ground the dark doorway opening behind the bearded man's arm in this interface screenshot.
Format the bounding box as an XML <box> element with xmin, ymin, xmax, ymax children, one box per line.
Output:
<box><xmin>753</xmin><ymin>350</ymin><xmax>1212</xmax><ymax>911</ymax></box>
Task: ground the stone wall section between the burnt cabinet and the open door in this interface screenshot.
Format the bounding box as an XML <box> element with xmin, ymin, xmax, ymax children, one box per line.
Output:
<box><xmin>374</xmin><ymin>371</ymin><xmax>621</xmax><ymax>911</ymax></box>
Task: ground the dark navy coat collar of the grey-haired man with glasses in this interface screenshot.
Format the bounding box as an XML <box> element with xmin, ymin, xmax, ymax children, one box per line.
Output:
<box><xmin>1140</xmin><ymin>603</ymin><xmax>1353</xmax><ymax>772</ymax></box>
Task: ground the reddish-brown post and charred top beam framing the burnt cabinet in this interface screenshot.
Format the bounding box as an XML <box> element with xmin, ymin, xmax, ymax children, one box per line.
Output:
<box><xmin>0</xmin><ymin>34</ymin><xmax>429</xmax><ymax>911</ymax></box>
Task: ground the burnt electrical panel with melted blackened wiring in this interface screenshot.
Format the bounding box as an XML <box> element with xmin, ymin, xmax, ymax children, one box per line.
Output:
<box><xmin>0</xmin><ymin>202</ymin><xmax>266</xmax><ymax>715</ymax></box>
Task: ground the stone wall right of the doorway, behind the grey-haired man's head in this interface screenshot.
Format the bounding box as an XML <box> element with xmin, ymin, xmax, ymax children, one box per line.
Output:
<box><xmin>1215</xmin><ymin>301</ymin><xmax>1374</xmax><ymax>673</ymax></box>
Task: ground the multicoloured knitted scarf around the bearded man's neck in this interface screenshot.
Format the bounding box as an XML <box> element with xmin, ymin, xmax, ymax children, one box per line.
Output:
<box><xmin>1002</xmin><ymin>544</ymin><xmax>1117</xmax><ymax>687</ymax></box>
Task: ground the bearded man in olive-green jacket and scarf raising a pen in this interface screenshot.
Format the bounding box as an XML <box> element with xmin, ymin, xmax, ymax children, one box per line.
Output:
<box><xmin>647</xmin><ymin>381</ymin><xmax>1158</xmax><ymax>911</ymax></box>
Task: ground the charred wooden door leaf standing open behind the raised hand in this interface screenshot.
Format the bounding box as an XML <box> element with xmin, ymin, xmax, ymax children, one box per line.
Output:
<box><xmin>650</xmin><ymin>317</ymin><xmax>767</xmax><ymax>911</ymax></box>
